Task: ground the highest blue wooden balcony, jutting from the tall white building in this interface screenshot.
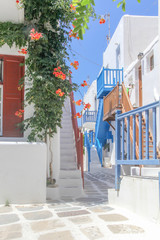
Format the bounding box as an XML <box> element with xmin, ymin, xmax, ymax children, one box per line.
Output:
<box><xmin>97</xmin><ymin>68</ymin><xmax>123</xmax><ymax>98</ymax></box>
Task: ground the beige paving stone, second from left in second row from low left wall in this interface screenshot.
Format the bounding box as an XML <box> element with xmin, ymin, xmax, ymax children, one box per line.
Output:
<box><xmin>23</xmin><ymin>211</ymin><xmax>53</xmax><ymax>220</ymax></box>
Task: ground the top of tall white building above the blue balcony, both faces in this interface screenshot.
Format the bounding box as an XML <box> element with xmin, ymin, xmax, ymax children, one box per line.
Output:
<box><xmin>103</xmin><ymin>15</ymin><xmax>158</xmax><ymax>70</ymax></box>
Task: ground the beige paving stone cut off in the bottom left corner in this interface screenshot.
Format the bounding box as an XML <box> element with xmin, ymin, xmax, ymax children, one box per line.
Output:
<box><xmin>0</xmin><ymin>224</ymin><xmax>22</xmax><ymax>240</ymax></box>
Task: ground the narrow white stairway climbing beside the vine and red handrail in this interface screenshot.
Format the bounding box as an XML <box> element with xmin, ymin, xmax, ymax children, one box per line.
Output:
<box><xmin>58</xmin><ymin>98</ymin><xmax>83</xmax><ymax>198</ymax></box>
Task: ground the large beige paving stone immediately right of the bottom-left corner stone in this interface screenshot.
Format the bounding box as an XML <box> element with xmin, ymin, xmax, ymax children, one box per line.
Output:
<box><xmin>31</xmin><ymin>219</ymin><xmax>65</xmax><ymax>232</ymax></box>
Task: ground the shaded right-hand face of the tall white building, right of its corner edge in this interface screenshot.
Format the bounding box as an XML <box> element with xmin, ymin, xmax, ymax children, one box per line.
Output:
<box><xmin>124</xmin><ymin>15</ymin><xmax>158</xmax><ymax>69</ymax></box>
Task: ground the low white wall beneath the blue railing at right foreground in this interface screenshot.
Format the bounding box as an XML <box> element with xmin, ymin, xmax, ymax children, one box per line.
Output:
<box><xmin>108</xmin><ymin>176</ymin><xmax>160</xmax><ymax>220</ymax></box>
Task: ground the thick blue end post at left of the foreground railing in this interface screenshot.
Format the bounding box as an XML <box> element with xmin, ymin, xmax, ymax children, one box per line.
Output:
<box><xmin>115</xmin><ymin>110</ymin><xmax>121</xmax><ymax>191</ymax></box>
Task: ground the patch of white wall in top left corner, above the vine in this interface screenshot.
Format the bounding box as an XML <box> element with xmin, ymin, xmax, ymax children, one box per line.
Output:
<box><xmin>0</xmin><ymin>0</ymin><xmax>24</xmax><ymax>23</ymax></box>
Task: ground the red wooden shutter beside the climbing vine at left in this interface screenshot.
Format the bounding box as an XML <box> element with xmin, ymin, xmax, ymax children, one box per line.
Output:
<box><xmin>0</xmin><ymin>55</ymin><xmax>24</xmax><ymax>137</ymax></box>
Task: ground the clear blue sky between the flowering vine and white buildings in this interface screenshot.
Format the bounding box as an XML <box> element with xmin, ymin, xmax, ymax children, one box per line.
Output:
<box><xmin>71</xmin><ymin>0</ymin><xmax>158</xmax><ymax>123</ymax></box>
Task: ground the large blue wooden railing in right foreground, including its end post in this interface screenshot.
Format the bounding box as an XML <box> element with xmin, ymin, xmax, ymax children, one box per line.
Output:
<box><xmin>115</xmin><ymin>101</ymin><xmax>160</xmax><ymax>190</ymax></box>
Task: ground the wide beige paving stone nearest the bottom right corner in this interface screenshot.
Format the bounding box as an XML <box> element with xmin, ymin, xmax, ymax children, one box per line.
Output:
<box><xmin>107</xmin><ymin>224</ymin><xmax>144</xmax><ymax>234</ymax></box>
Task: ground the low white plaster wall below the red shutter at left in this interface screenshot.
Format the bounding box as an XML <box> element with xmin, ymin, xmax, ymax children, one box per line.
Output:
<box><xmin>0</xmin><ymin>142</ymin><xmax>47</xmax><ymax>204</ymax></box>
